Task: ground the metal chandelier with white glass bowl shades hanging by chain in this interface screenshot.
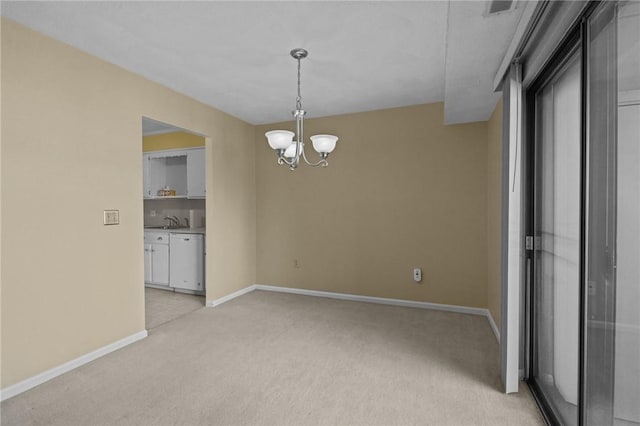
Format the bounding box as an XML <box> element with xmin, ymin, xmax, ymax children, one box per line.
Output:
<box><xmin>264</xmin><ymin>49</ymin><xmax>338</xmax><ymax>170</ymax></box>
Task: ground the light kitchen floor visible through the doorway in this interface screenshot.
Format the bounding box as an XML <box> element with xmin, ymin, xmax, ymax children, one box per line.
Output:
<box><xmin>144</xmin><ymin>287</ymin><xmax>205</xmax><ymax>330</ymax></box>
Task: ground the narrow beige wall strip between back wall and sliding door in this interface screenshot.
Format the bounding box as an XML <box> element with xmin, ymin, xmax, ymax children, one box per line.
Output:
<box><xmin>487</xmin><ymin>99</ymin><xmax>502</xmax><ymax>329</ymax></box>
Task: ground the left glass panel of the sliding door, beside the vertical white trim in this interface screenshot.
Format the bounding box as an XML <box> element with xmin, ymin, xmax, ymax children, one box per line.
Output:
<box><xmin>531</xmin><ymin>45</ymin><xmax>582</xmax><ymax>425</ymax></box>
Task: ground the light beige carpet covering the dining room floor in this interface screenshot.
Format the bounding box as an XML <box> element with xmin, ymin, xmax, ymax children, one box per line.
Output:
<box><xmin>2</xmin><ymin>291</ymin><xmax>543</xmax><ymax>425</ymax></box>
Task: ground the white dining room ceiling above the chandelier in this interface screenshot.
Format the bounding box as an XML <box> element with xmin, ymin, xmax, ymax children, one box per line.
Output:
<box><xmin>1</xmin><ymin>1</ymin><xmax>525</xmax><ymax>124</ymax></box>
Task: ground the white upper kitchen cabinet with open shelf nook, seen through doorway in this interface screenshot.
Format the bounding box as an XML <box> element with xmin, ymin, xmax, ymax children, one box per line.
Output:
<box><xmin>142</xmin><ymin>148</ymin><xmax>206</xmax><ymax>198</ymax></box>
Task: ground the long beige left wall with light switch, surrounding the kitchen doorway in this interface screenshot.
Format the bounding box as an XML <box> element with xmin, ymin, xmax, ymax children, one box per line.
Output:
<box><xmin>1</xmin><ymin>19</ymin><xmax>256</xmax><ymax>388</ymax></box>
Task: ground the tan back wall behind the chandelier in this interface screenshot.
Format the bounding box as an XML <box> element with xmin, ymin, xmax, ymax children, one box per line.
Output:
<box><xmin>256</xmin><ymin>103</ymin><xmax>487</xmax><ymax>307</ymax></box>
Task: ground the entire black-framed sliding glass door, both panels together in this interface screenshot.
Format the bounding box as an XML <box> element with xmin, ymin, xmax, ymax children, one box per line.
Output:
<box><xmin>527</xmin><ymin>2</ymin><xmax>640</xmax><ymax>426</ymax></box>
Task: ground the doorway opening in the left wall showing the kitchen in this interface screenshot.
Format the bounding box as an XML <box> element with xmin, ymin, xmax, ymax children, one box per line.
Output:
<box><xmin>141</xmin><ymin>117</ymin><xmax>206</xmax><ymax>330</ymax></box>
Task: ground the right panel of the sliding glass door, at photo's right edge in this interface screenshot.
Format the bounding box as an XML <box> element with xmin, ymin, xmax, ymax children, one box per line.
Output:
<box><xmin>584</xmin><ymin>2</ymin><xmax>640</xmax><ymax>425</ymax></box>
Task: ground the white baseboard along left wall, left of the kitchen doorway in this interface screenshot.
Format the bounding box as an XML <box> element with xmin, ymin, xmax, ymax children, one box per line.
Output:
<box><xmin>0</xmin><ymin>330</ymin><xmax>147</xmax><ymax>401</ymax></box>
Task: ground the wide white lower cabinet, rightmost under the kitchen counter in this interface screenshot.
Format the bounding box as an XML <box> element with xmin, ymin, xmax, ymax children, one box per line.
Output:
<box><xmin>169</xmin><ymin>233</ymin><xmax>204</xmax><ymax>291</ymax></box>
